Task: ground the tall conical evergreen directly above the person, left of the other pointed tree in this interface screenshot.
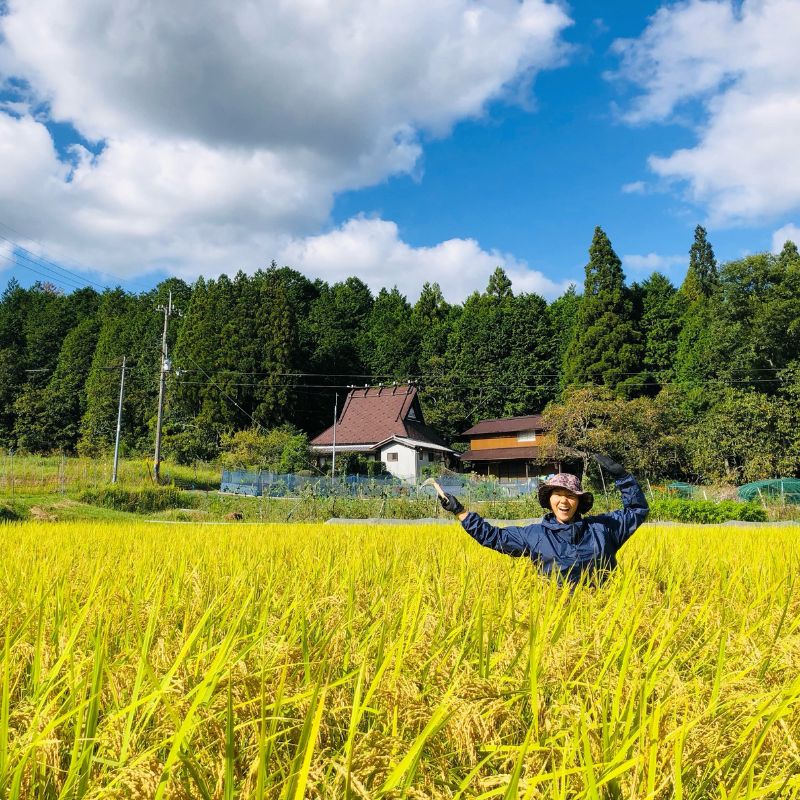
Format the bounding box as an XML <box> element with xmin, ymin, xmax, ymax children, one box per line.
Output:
<box><xmin>564</xmin><ymin>227</ymin><xmax>641</xmax><ymax>394</ymax></box>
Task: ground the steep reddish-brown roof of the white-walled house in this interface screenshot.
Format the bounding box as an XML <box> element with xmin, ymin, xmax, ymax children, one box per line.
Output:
<box><xmin>310</xmin><ymin>386</ymin><xmax>447</xmax><ymax>449</ymax></box>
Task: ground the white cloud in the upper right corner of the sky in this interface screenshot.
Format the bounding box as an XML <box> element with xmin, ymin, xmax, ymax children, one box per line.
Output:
<box><xmin>614</xmin><ymin>0</ymin><xmax>800</xmax><ymax>224</ymax></box>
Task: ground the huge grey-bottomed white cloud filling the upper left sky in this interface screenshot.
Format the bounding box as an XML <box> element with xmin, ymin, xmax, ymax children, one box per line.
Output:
<box><xmin>0</xmin><ymin>0</ymin><xmax>570</xmax><ymax>281</ymax></box>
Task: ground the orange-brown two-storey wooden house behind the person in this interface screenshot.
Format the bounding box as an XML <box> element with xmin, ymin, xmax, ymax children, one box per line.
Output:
<box><xmin>461</xmin><ymin>414</ymin><xmax>561</xmax><ymax>481</ymax></box>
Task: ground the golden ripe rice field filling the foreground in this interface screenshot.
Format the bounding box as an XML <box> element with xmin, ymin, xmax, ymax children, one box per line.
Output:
<box><xmin>0</xmin><ymin>523</ymin><xmax>800</xmax><ymax>800</ymax></box>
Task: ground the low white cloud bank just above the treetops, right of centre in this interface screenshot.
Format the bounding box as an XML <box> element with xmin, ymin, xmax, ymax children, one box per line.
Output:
<box><xmin>279</xmin><ymin>217</ymin><xmax>570</xmax><ymax>302</ymax></box>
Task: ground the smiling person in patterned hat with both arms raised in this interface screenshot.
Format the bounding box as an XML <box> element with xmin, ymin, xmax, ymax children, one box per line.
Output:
<box><xmin>440</xmin><ymin>455</ymin><xmax>649</xmax><ymax>583</ymax></box>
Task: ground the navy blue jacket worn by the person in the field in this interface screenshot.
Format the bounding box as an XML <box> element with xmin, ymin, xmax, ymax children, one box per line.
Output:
<box><xmin>461</xmin><ymin>475</ymin><xmax>649</xmax><ymax>583</ymax></box>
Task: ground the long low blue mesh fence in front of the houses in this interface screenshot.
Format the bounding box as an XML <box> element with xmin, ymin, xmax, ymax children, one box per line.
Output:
<box><xmin>220</xmin><ymin>470</ymin><xmax>539</xmax><ymax>500</ymax></box>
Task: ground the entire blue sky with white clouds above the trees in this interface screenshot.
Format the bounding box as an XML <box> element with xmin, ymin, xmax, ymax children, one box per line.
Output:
<box><xmin>0</xmin><ymin>0</ymin><xmax>800</xmax><ymax>300</ymax></box>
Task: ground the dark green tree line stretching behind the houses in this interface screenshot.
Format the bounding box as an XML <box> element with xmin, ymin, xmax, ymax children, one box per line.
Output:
<box><xmin>0</xmin><ymin>226</ymin><xmax>800</xmax><ymax>481</ymax></box>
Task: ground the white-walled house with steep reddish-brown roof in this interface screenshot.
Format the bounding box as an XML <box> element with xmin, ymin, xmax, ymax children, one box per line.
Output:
<box><xmin>309</xmin><ymin>385</ymin><xmax>457</xmax><ymax>483</ymax></box>
